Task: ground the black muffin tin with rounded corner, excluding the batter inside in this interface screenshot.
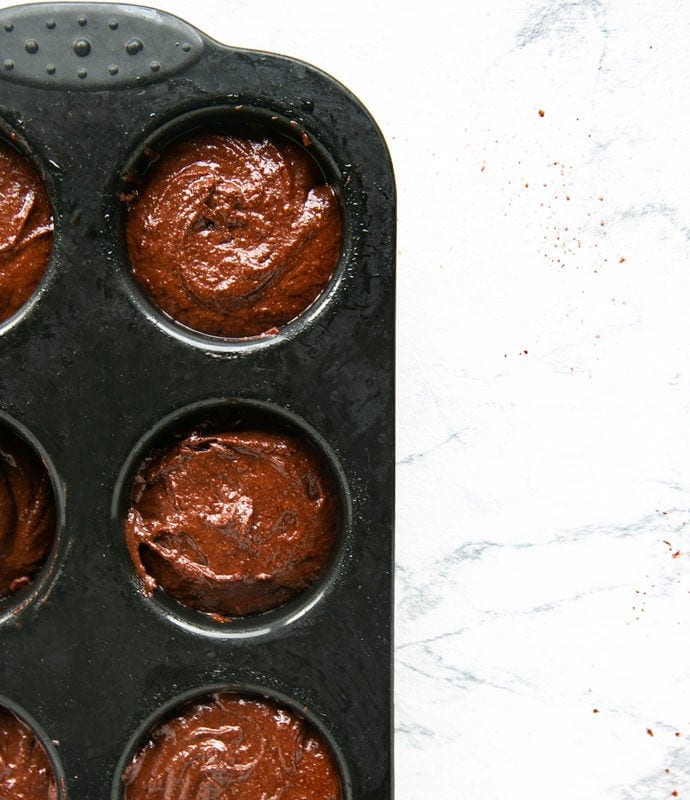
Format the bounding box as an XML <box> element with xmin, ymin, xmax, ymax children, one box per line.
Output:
<box><xmin>0</xmin><ymin>4</ymin><xmax>395</xmax><ymax>800</ymax></box>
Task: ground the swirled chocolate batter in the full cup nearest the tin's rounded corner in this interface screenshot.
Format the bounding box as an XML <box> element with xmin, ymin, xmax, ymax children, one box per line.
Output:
<box><xmin>127</xmin><ymin>134</ymin><xmax>341</xmax><ymax>337</ymax></box>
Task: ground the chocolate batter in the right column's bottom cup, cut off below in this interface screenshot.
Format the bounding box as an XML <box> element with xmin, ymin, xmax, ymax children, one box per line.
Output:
<box><xmin>122</xmin><ymin>694</ymin><xmax>342</xmax><ymax>800</ymax></box>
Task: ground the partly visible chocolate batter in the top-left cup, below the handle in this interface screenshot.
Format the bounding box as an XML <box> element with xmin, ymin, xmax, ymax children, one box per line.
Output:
<box><xmin>0</xmin><ymin>141</ymin><xmax>53</xmax><ymax>322</ymax></box>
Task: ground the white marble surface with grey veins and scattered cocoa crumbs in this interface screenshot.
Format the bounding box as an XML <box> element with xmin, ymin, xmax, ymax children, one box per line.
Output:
<box><xmin>5</xmin><ymin>0</ymin><xmax>690</xmax><ymax>800</ymax></box>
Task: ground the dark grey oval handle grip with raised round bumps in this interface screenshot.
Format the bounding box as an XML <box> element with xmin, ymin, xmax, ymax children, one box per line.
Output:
<box><xmin>0</xmin><ymin>3</ymin><xmax>204</xmax><ymax>90</ymax></box>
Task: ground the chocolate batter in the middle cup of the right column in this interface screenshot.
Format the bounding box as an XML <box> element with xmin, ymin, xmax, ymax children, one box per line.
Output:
<box><xmin>126</xmin><ymin>430</ymin><xmax>338</xmax><ymax>617</ymax></box>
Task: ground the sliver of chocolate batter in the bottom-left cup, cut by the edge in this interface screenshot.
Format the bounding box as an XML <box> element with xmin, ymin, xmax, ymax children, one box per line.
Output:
<box><xmin>0</xmin><ymin>707</ymin><xmax>58</xmax><ymax>800</ymax></box>
